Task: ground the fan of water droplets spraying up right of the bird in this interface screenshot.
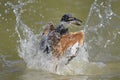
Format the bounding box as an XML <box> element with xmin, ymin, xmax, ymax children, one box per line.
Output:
<box><xmin>85</xmin><ymin>0</ymin><xmax>120</xmax><ymax>62</ymax></box>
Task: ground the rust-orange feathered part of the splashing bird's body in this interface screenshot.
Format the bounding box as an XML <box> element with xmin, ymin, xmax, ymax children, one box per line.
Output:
<box><xmin>53</xmin><ymin>31</ymin><xmax>84</xmax><ymax>57</ymax></box>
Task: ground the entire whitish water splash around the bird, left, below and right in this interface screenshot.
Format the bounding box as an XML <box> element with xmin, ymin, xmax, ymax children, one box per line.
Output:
<box><xmin>7</xmin><ymin>0</ymin><xmax>120</xmax><ymax>75</ymax></box>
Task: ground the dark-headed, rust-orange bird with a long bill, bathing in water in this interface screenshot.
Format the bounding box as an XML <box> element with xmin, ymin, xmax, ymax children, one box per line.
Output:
<box><xmin>40</xmin><ymin>14</ymin><xmax>84</xmax><ymax>58</ymax></box>
